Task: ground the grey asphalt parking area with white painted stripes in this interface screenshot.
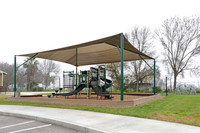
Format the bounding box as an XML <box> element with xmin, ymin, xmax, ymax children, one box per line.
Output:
<box><xmin>0</xmin><ymin>115</ymin><xmax>79</xmax><ymax>133</ymax></box>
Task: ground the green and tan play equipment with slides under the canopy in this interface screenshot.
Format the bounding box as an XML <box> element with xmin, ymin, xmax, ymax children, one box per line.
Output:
<box><xmin>62</xmin><ymin>66</ymin><xmax>112</xmax><ymax>99</ymax></box>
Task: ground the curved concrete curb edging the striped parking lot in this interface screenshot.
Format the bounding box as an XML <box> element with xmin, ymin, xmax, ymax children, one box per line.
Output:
<box><xmin>0</xmin><ymin>111</ymin><xmax>110</xmax><ymax>133</ymax></box>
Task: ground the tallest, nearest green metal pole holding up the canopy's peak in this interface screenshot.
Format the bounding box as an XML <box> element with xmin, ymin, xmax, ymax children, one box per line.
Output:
<box><xmin>120</xmin><ymin>33</ymin><xmax>124</xmax><ymax>101</ymax></box>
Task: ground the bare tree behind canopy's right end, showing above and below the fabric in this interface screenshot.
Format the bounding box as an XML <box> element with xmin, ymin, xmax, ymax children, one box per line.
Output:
<box><xmin>125</xmin><ymin>26</ymin><xmax>155</xmax><ymax>92</ymax></box>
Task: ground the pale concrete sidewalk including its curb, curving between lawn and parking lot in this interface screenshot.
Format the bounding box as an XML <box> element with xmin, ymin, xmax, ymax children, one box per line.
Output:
<box><xmin>0</xmin><ymin>105</ymin><xmax>200</xmax><ymax>133</ymax></box>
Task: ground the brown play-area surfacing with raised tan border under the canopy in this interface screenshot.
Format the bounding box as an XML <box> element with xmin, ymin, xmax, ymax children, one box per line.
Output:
<box><xmin>8</xmin><ymin>95</ymin><xmax>162</xmax><ymax>108</ymax></box>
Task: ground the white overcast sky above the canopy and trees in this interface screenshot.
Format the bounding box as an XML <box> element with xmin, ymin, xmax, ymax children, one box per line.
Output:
<box><xmin>0</xmin><ymin>0</ymin><xmax>200</xmax><ymax>83</ymax></box>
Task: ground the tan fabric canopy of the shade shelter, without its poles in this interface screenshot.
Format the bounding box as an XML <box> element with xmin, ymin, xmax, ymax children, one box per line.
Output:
<box><xmin>19</xmin><ymin>33</ymin><xmax>152</xmax><ymax>66</ymax></box>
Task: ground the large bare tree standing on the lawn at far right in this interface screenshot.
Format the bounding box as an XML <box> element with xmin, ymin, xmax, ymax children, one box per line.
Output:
<box><xmin>156</xmin><ymin>17</ymin><xmax>200</xmax><ymax>90</ymax></box>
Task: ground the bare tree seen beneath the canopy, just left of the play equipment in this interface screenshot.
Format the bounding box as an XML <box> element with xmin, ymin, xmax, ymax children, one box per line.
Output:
<box><xmin>39</xmin><ymin>60</ymin><xmax>60</xmax><ymax>90</ymax></box>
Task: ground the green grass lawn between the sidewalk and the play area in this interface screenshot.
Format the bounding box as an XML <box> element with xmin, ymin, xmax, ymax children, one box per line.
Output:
<box><xmin>0</xmin><ymin>94</ymin><xmax>200</xmax><ymax>126</ymax></box>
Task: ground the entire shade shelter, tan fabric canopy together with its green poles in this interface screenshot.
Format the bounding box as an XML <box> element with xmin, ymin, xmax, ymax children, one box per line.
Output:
<box><xmin>14</xmin><ymin>33</ymin><xmax>156</xmax><ymax>101</ymax></box>
